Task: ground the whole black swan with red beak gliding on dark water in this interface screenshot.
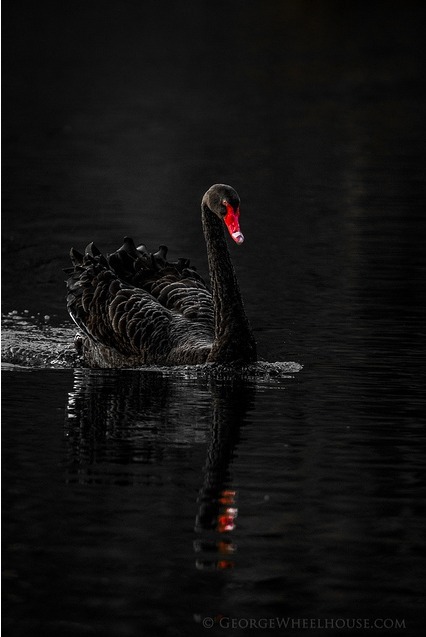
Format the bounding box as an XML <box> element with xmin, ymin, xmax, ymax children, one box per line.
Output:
<box><xmin>65</xmin><ymin>184</ymin><xmax>256</xmax><ymax>367</ymax></box>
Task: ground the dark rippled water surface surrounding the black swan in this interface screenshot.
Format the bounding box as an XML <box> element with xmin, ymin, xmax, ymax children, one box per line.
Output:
<box><xmin>2</xmin><ymin>0</ymin><xmax>426</xmax><ymax>637</ymax></box>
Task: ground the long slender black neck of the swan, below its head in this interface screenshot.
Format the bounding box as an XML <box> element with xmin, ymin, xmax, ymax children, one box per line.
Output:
<box><xmin>202</xmin><ymin>203</ymin><xmax>256</xmax><ymax>363</ymax></box>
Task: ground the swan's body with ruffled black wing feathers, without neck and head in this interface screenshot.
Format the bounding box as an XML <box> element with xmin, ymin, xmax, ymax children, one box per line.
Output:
<box><xmin>66</xmin><ymin>238</ymin><xmax>214</xmax><ymax>367</ymax></box>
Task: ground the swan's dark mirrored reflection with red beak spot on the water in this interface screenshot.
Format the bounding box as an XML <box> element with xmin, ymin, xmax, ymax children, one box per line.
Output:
<box><xmin>65</xmin><ymin>369</ymin><xmax>255</xmax><ymax>569</ymax></box>
